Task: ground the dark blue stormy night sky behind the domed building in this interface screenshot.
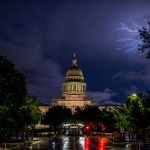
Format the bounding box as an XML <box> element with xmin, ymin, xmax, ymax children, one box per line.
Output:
<box><xmin>0</xmin><ymin>0</ymin><xmax>150</xmax><ymax>104</ymax></box>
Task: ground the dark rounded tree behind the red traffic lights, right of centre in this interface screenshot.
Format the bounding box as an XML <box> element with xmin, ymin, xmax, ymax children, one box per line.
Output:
<box><xmin>75</xmin><ymin>106</ymin><xmax>114</xmax><ymax>131</ymax></box>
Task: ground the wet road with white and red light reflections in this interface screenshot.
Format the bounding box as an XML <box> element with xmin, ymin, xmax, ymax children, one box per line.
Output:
<box><xmin>24</xmin><ymin>136</ymin><xmax>130</xmax><ymax>150</ymax></box>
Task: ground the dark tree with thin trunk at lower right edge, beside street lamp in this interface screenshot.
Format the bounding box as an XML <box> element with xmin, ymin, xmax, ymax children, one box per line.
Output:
<box><xmin>126</xmin><ymin>94</ymin><xmax>150</xmax><ymax>144</ymax></box>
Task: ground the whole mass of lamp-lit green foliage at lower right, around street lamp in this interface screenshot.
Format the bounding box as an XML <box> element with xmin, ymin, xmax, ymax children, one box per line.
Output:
<box><xmin>115</xmin><ymin>94</ymin><xmax>150</xmax><ymax>132</ymax></box>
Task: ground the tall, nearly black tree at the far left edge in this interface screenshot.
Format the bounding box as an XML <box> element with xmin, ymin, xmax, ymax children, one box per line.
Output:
<box><xmin>0</xmin><ymin>54</ymin><xmax>27</xmax><ymax>141</ymax></box>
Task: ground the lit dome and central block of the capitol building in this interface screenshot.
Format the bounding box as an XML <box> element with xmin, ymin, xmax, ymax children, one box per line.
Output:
<box><xmin>51</xmin><ymin>54</ymin><xmax>94</xmax><ymax>112</ymax></box>
